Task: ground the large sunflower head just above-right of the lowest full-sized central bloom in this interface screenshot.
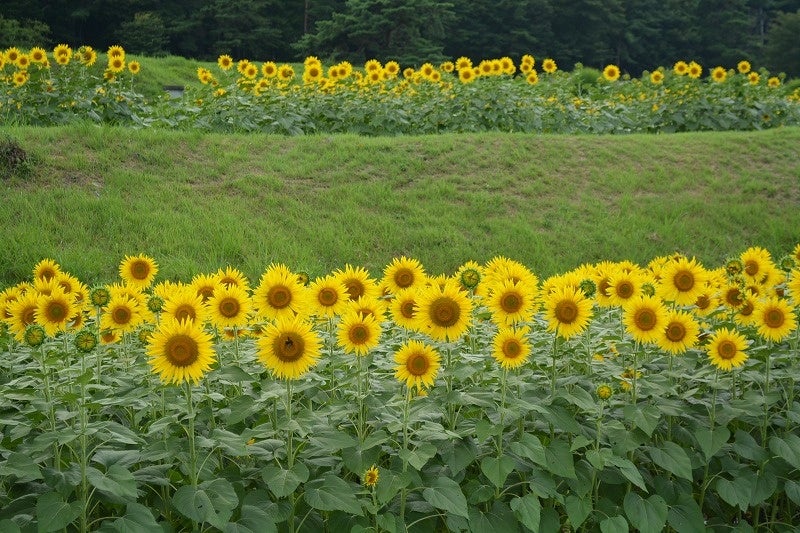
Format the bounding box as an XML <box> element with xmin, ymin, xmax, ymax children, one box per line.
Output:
<box><xmin>415</xmin><ymin>281</ymin><xmax>472</xmax><ymax>341</ymax></box>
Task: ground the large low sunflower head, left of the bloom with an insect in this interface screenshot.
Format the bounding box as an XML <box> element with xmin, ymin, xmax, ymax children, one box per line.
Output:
<box><xmin>147</xmin><ymin>318</ymin><xmax>215</xmax><ymax>385</ymax></box>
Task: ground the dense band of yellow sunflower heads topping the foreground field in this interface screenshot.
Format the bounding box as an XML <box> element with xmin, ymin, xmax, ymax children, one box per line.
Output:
<box><xmin>0</xmin><ymin>245</ymin><xmax>800</xmax><ymax>386</ymax></box>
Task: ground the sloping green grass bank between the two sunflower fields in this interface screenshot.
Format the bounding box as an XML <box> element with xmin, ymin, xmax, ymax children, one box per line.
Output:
<box><xmin>0</xmin><ymin>125</ymin><xmax>800</xmax><ymax>285</ymax></box>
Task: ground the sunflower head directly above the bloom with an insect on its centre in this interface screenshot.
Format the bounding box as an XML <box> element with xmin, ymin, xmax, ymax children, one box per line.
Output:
<box><xmin>253</xmin><ymin>264</ymin><xmax>311</xmax><ymax>319</ymax></box>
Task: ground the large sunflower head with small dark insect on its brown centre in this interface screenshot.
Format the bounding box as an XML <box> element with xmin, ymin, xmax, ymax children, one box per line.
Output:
<box><xmin>256</xmin><ymin>317</ymin><xmax>321</xmax><ymax>380</ymax></box>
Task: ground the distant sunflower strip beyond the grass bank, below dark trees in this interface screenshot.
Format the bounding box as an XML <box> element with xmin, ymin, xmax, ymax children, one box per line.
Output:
<box><xmin>0</xmin><ymin>45</ymin><xmax>800</xmax><ymax>135</ymax></box>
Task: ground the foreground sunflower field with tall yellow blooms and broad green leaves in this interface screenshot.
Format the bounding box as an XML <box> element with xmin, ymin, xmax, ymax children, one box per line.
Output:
<box><xmin>0</xmin><ymin>244</ymin><xmax>800</xmax><ymax>532</ymax></box>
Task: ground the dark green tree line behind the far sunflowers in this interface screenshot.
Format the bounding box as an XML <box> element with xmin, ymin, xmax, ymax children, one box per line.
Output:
<box><xmin>0</xmin><ymin>0</ymin><xmax>800</xmax><ymax>76</ymax></box>
